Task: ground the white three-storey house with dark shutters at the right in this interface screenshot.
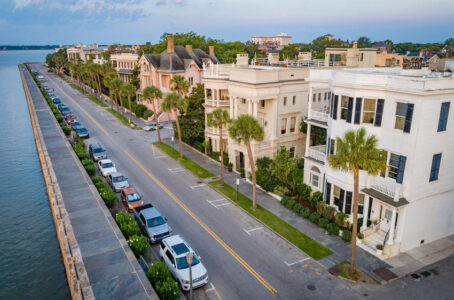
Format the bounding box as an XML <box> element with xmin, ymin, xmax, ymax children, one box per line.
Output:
<box><xmin>304</xmin><ymin>68</ymin><xmax>454</xmax><ymax>257</ymax></box>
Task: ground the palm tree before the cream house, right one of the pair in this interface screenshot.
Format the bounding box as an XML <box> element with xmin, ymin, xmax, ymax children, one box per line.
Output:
<box><xmin>229</xmin><ymin>115</ymin><xmax>264</xmax><ymax>210</ymax></box>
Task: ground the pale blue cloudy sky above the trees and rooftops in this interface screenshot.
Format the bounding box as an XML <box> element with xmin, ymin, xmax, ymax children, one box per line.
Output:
<box><xmin>0</xmin><ymin>0</ymin><xmax>454</xmax><ymax>45</ymax></box>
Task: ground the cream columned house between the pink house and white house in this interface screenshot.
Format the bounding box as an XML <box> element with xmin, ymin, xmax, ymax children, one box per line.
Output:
<box><xmin>203</xmin><ymin>54</ymin><xmax>331</xmax><ymax>171</ymax></box>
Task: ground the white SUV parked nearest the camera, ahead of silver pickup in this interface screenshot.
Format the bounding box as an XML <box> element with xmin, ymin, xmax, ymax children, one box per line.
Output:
<box><xmin>159</xmin><ymin>235</ymin><xmax>208</xmax><ymax>291</ymax></box>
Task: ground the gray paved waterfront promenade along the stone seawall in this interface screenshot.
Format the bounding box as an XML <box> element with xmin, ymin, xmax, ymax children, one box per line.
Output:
<box><xmin>19</xmin><ymin>65</ymin><xmax>157</xmax><ymax>299</ymax></box>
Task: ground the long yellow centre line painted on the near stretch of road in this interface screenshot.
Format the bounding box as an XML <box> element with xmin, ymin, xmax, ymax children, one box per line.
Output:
<box><xmin>124</xmin><ymin>150</ymin><xmax>277</xmax><ymax>294</ymax></box>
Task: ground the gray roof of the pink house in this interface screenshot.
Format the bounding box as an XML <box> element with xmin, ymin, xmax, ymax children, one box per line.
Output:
<box><xmin>144</xmin><ymin>46</ymin><xmax>219</xmax><ymax>72</ymax></box>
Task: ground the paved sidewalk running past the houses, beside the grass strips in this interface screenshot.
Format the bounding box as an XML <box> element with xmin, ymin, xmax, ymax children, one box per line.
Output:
<box><xmin>163</xmin><ymin>139</ymin><xmax>391</xmax><ymax>281</ymax></box>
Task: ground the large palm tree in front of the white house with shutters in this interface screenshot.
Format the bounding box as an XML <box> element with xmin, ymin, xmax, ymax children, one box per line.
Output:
<box><xmin>328</xmin><ymin>128</ymin><xmax>386</xmax><ymax>274</ymax></box>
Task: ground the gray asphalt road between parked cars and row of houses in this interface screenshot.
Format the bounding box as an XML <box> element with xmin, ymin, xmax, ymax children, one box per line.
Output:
<box><xmin>33</xmin><ymin>64</ymin><xmax>432</xmax><ymax>299</ymax></box>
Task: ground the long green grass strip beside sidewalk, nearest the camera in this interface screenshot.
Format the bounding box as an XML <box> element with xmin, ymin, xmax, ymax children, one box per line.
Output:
<box><xmin>210</xmin><ymin>180</ymin><xmax>333</xmax><ymax>260</ymax></box>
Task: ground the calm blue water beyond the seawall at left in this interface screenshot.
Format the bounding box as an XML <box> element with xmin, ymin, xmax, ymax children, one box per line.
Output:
<box><xmin>0</xmin><ymin>51</ymin><xmax>70</xmax><ymax>299</ymax></box>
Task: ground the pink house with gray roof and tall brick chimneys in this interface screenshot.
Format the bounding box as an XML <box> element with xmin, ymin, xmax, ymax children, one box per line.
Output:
<box><xmin>137</xmin><ymin>36</ymin><xmax>219</xmax><ymax>121</ymax></box>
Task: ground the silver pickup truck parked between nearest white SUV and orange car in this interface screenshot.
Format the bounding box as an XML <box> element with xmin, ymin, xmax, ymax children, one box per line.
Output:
<box><xmin>133</xmin><ymin>203</ymin><xmax>172</xmax><ymax>243</ymax></box>
